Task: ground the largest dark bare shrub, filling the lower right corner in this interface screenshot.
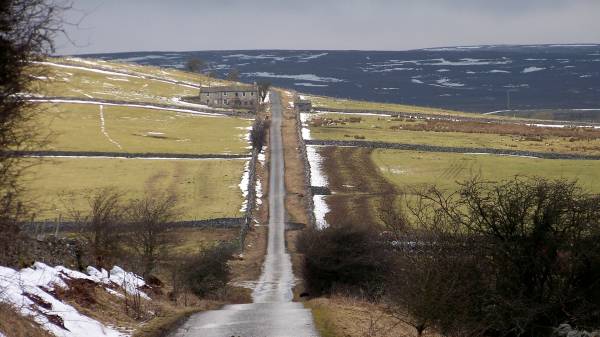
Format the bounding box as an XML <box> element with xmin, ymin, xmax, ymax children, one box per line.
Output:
<box><xmin>390</xmin><ymin>177</ymin><xmax>600</xmax><ymax>336</ymax></box>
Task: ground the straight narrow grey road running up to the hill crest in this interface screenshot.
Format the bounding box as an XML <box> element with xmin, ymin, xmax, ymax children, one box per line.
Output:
<box><xmin>172</xmin><ymin>91</ymin><xmax>318</xmax><ymax>337</ymax></box>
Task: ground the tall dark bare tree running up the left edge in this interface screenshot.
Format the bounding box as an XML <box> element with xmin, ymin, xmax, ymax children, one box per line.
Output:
<box><xmin>0</xmin><ymin>0</ymin><xmax>69</xmax><ymax>264</ymax></box>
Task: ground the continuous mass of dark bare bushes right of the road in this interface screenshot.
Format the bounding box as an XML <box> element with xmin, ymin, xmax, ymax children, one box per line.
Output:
<box><xmin>299</xmin><ymin>177</ymin><xmax>600</xmax><ymax>336</ymax></box>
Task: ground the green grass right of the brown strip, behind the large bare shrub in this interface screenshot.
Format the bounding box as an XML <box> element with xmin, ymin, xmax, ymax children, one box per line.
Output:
<box><xmin>372</xmin><ymin>150</ymin><xmax>600</xmax><ymax>192</ymax></box>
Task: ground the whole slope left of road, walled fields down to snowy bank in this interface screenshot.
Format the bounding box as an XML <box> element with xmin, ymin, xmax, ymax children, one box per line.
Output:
<box><xmin>0</xmin><ymin>58</ymin><xmax>265</xmax><ymax>336</ymax></box>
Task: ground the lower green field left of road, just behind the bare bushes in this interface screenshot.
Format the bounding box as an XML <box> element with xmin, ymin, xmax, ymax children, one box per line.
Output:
<box><xmin>26</xmin><ymin>158</ymin><xmax>244</xmax><ymax>220</ymax></box>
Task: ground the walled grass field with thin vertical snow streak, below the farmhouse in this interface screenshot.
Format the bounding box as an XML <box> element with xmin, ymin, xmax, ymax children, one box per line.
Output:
<box><xmin>33</xmin><ymin>104</ymin><xmax>252</xmax><ymax>154</ymax></box>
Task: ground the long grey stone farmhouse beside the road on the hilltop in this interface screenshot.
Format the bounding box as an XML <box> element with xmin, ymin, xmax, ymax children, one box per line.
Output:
<box><xmin>199</xmin><ymin>85</ymin><xmax>259</xmax><ymax>109</ymax></box>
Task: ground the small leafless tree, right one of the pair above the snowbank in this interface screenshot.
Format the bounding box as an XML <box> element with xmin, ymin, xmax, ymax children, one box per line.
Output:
<box><xmin>126</xmin><ymin>195</ymin><xmax>178</xmax><ymax>277</ymax></box>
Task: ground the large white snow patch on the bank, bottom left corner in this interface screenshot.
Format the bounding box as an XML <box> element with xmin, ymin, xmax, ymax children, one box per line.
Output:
<box><xmin>0</xmin><ymin>262</ymin><xmax>149</xmax><ymax>337</ymax></box>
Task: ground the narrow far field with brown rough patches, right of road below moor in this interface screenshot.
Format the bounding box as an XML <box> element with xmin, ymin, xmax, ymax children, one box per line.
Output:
<box><xmin>310</xmin><ymin>114</ymin><xmax>600</xmax><ymax>154</ymax></box>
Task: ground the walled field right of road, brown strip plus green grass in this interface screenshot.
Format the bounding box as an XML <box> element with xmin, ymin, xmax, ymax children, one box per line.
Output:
<box><xmin>318</xmin><ymin>147</ymin><xmax>600</xmax><ymax>225</ymax></box>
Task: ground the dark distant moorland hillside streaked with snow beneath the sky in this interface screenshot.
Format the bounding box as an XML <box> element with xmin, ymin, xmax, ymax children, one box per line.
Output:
<box><xmin>77</xmin><ymin>44</ymin><xmax>600</xmax><ymax>113</ymax></box>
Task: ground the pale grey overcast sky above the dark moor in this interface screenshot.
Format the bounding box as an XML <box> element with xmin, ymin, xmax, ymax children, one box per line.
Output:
<box><xmin>57</xmin><ymin>0</ymin><xmax>600</xmax><ymax>54</ymax></box>
